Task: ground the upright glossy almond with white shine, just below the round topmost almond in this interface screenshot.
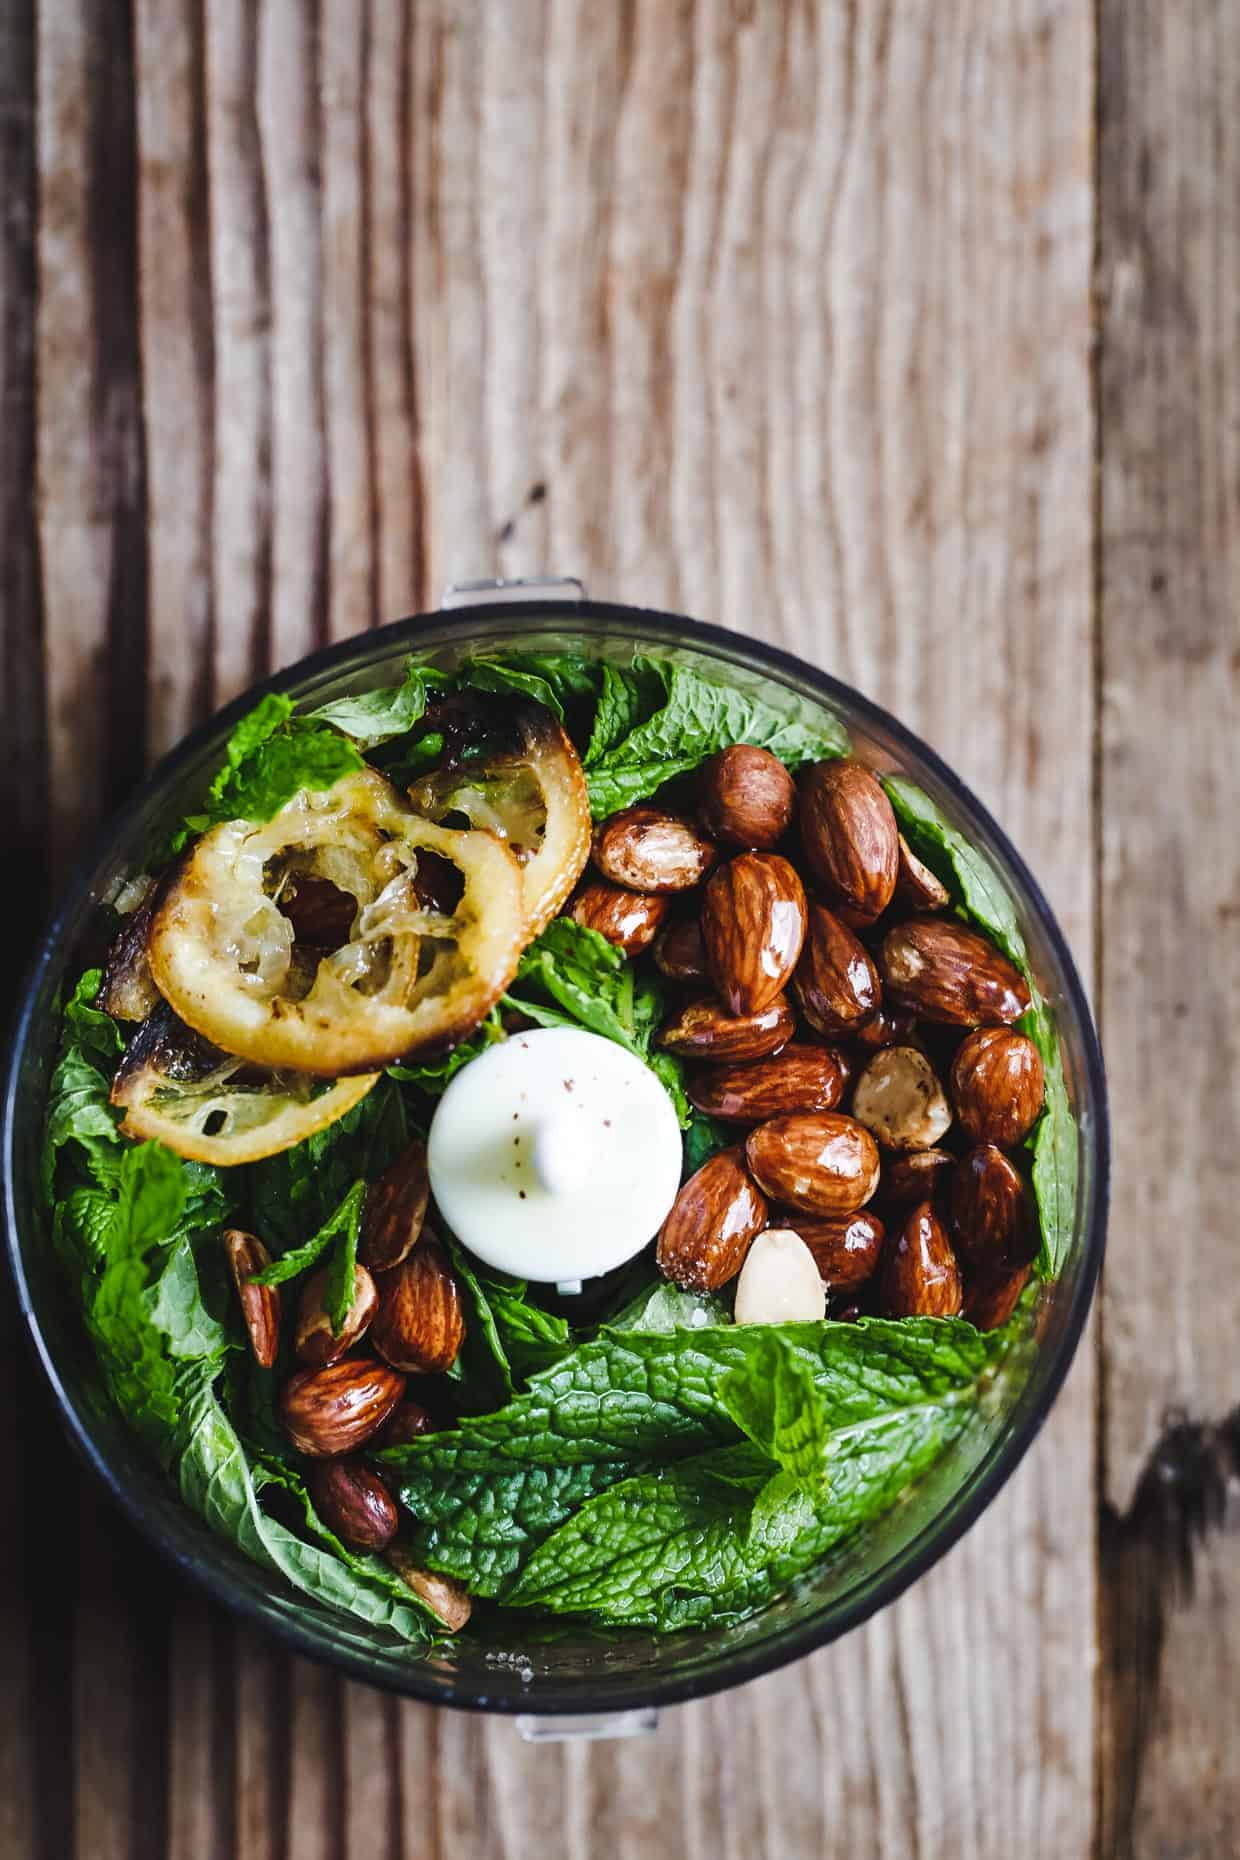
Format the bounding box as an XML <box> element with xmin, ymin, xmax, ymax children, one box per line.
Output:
<box><xmin>701</xmin><ymin>852</ymin><xmax>805</xmax><ymax>1014</ymax></box>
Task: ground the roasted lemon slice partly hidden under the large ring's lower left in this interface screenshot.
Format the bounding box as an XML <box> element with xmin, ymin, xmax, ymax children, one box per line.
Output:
<box><xmin>112</xmin><ymin>1003</ymin><xmax>379</xmax><ymax>1168</ymax></box>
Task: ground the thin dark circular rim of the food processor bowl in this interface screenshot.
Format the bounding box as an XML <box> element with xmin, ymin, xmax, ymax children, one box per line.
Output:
<box><xmin>0</xmin><ymin>597</ymin><xmax>1110</xmax><ymax>1717</ymax></box>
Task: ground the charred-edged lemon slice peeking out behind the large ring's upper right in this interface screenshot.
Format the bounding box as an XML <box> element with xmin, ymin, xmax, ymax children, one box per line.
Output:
<box><xmin>409</xmin><ymin>703</ymin><xmax>591</xmax><ymax>937</ymax></box>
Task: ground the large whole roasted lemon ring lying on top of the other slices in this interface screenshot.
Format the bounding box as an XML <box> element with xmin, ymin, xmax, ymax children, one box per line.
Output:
<box><xmin>147</xmin><ymin>768</ymin><xmax>530</xmax><ymax>1079</ymax></box>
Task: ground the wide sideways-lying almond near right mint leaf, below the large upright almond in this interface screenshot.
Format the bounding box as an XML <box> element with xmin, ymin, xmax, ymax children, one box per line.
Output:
<box><xmin>879</xmin><ymin>917</ymin><xmax>1030</xmax><ymax>1027</ymax></box>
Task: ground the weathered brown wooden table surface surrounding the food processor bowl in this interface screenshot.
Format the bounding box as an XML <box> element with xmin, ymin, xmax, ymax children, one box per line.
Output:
<box><xmin>0</xmin><ymin>0</ymin><xmax>1240</xmax><ymax>1860</ymax></box>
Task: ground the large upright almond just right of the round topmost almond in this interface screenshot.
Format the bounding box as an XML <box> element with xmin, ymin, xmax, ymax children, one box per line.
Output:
<box><xmin>798</xmin><ymin>759</ymin><xmax>900</xmax><ymax>926</ymax></box>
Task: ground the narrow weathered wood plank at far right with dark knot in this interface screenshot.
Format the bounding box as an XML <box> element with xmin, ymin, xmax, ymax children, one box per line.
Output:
<box><xmin>1099</xmin><ymin>0</ymin><xmax>1240</xmax><ymax>1860</ymax></box>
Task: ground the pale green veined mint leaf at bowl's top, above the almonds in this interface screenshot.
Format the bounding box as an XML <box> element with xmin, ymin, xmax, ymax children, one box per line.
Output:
<box><xmin>586</xmin><ymin>662</ymin><xmax>848</xmax><ymax>818</ymax></box>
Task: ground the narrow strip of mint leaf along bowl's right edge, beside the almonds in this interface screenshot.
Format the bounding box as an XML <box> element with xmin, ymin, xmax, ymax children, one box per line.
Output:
<box><xmin>883</xmin><ymin>776</ymin><xmax>1078</xmax><ymax>1280</ymax></box>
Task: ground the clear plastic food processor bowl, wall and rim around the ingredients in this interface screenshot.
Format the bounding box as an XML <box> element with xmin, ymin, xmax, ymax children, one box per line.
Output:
<box><xmin>4</xmin><ymin>597</ymin><xmax>1108</xmax><ymax>1728</ymax></box>
